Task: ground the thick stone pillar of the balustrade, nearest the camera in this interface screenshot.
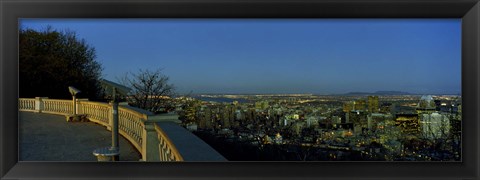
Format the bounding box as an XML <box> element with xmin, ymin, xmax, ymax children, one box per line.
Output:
<box><xmin>142</xmin><ymin>120</ymin><xmax>160</xmax><ymax>161</ymax></box>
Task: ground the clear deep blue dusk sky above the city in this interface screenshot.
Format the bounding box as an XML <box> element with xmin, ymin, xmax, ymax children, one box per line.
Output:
<box><xmin>20</xmin><ymin>19</ymin><xmax>461</xmax><ymax>94</ymax></box>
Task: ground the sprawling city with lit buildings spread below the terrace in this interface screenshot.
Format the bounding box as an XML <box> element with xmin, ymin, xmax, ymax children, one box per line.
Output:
<box><xmin>173</xmin><ymin>95</ymin><xmax>461</xmax><ymax>161</ymax></box>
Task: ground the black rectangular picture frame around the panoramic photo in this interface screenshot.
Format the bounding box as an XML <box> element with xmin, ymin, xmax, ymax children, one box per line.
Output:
<box><xmin>0</xmin><ymin>0</ymin><xmax>480</xmax><ymax>180</ymax></box>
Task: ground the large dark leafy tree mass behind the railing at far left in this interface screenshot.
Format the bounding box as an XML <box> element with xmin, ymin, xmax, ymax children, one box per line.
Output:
<box><xmin>19</xmin><ymin>27</ymin><xmax>102</xmax><ymax>99</ymax></box>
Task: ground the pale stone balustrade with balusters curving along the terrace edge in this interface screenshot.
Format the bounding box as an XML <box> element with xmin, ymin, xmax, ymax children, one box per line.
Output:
<box><xmin>18</xmin><ymin>97</ymin><xmax>182</xmax><ymax>161</ymax></box>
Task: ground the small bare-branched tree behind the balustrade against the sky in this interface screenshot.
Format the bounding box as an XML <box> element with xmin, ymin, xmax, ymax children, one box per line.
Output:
<box><xmin>120</xmin><ymin>69</ymin><xmax>175</xmax><ymax>112</ymax></box>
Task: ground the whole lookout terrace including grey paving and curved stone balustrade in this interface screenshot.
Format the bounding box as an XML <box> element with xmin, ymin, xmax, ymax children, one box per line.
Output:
<box><xmin>19</xmin><ymin>97</ymin><xmax>227</xmax><ymax>161</ymax></box>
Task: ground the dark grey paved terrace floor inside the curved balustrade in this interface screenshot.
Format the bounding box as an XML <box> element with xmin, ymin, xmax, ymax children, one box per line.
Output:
<box><xmin>19</xmin><ymin>112</ymin><xmax>141</xmax><ymax>161</ymax></box>
